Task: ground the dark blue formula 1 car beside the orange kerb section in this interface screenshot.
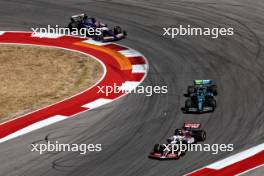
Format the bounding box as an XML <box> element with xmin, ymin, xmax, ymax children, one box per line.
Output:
<box><xmin>67</xmin><ymin>14</ymin><xmax>127</xmax><ymax>42</ymax></box>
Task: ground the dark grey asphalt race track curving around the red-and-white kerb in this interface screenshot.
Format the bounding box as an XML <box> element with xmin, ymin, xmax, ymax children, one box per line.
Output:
<box><xmin>0</xmin><ymin>0</ymin><xmax>264</xmax><ymax>176</ymax></box>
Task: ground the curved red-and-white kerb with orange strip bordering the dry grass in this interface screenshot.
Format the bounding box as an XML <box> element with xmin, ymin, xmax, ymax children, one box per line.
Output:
<box><xmin>0</xmin><ymin>31</ymin><xmax>148</xmax><ymax>143</ymax></box>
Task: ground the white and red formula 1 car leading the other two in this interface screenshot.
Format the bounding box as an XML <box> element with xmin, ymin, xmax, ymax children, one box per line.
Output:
<box><xmin>149</xmin><ymin>123</ymin><xmax>206</xmax><ymax>160</ymax></box>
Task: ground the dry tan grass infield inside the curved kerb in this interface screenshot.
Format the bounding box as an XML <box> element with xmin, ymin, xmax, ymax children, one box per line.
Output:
<box><xmin>0</xmin><ymin>45</ymin><xmax>103</xmax><ymax>122</ymax></box>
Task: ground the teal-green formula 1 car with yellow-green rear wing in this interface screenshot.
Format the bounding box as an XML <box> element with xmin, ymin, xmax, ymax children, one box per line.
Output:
<box><xmin>184</xmin><ymin>80</ymin><xmax>217</xmax><ymax>113</ymax></box>
